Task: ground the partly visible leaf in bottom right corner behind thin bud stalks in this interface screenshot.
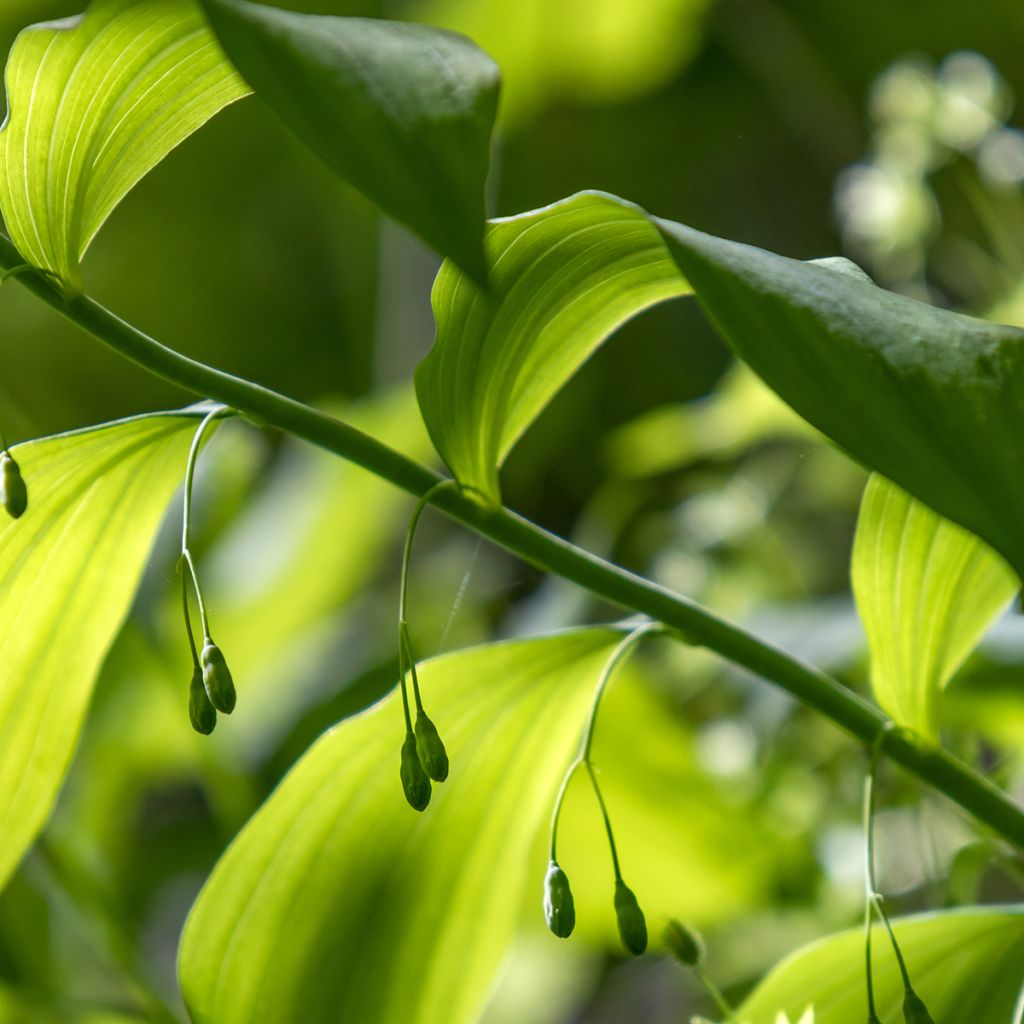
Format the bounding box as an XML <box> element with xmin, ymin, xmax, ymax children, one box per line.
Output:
<box><xmin>736</xmin><ymin>906</ymin><xmax>1024</xmax><ymax>1024</ymax></box>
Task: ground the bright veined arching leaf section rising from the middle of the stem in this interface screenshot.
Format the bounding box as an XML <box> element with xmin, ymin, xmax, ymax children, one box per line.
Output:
<box><xmin>416</xmin><ymin>193</ymin><xmax>688</xmax><ymax>501</ymax></box>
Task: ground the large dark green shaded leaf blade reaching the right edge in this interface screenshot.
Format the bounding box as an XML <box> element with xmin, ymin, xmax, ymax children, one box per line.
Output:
<box><xmin>658</xmin><ymin>221</ymin><xmax>1024</xmax><ymax>575</ymax></box>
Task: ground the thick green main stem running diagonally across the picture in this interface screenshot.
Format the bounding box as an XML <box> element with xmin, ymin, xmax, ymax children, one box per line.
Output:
<box><xmin>8</xmin><ymin>245</ymin><xmax>1024</xmax><ymax>849</ymax></box>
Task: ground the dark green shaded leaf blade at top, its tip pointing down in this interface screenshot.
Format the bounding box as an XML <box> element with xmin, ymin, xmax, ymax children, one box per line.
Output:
<box><xmin>203</xmin><ymin>0</ymin><xmax>499</xmax><ymax>283</ymax></box>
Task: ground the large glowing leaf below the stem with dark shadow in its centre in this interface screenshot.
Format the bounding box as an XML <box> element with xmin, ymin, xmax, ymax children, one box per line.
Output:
<box><xmin>179</xmin><ymin>630</ymin><xmax>621</xmax><ymax>1024</ymax></box>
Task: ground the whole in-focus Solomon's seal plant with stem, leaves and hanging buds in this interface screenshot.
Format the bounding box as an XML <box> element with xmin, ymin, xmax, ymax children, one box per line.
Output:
<box><xmin>0</xmin><ymin>0</ymin><xmax>1024</xmax><ymax>1024</ymax></box>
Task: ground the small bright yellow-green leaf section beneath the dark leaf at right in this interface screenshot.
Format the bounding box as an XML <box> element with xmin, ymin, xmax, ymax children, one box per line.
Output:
<box><xmin>851</xmin><ymin>474</ymin><xmax>1020</xmax><ymax>739</ymax></box>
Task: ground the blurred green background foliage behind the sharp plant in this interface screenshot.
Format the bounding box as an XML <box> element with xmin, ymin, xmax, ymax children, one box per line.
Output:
<box><xmin>0</xmin><ymin>0</ymin><xmax>1024</xmax><ymax>1024</ymax></box>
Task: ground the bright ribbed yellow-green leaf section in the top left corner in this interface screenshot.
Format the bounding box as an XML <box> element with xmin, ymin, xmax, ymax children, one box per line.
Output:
<box><xmin>0</xmin><ymin>0</ymin><xmax>249</xmax><ymax>291</ymax></box>
